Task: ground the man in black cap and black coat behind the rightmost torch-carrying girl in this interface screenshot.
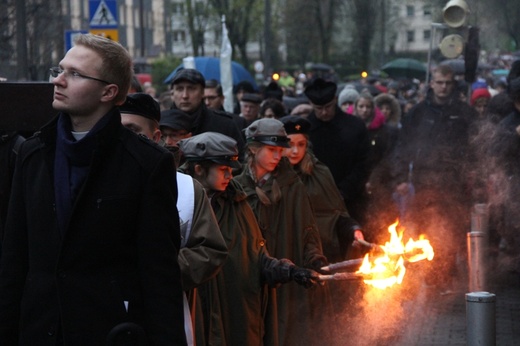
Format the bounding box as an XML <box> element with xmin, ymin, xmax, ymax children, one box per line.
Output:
<box><xmin>305</xmin><ymin>78</ymin><xmax>371</xmax><ymax>225</ymax></box>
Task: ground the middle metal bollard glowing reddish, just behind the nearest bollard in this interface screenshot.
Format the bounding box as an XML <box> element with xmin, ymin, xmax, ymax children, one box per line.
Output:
<box><xmin>467</xmin><ymin>232</ymin><xmax>487</xmax><ymax>292</ymax></box>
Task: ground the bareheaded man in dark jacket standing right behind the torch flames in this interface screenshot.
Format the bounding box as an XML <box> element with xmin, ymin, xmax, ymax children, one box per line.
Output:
<box><xmin>392</xmin><ymin>65</ymin><xmax>477</xmax><ymax>293</ymax></box>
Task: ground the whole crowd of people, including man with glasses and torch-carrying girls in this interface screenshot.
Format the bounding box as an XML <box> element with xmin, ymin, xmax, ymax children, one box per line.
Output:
<box><xmin>0</xmin><ymin>35</ymin><xmax>520</xmax><ymax>346</ymax></box>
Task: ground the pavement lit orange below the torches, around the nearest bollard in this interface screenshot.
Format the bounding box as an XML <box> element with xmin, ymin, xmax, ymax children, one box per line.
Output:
<box><xmin>323</xmin><ymin>253</ymin><xmax>520</xmax><ymax>346</ymax></box>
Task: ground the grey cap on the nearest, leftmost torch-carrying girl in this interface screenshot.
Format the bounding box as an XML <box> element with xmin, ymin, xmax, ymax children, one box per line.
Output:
<box><xmin>178</xmin><ymin>132</ymin><xmax>240</xmax><ymax>168</ymax></box>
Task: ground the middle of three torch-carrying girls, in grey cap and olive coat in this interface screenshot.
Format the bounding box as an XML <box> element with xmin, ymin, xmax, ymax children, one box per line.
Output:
<box><xmin>234</xmin><ymin>118</ymin><xmax>330</xmax><ymax>345</ymax></box>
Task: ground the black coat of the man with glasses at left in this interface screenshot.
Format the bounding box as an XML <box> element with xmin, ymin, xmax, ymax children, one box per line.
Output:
<box><xmin>0</xmin><ymin>109</ymin><xmax>186</xmax><ymax>346</ymax></box>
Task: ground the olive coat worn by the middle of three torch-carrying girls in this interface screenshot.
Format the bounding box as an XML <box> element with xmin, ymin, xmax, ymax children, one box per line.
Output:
<box><xmin>234</xmin><ymin>158</ymin><xmax>328</xmax><ymax>345</ymax></box>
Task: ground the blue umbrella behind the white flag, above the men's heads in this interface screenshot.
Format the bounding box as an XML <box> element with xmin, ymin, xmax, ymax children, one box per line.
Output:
<box><xmin>164</xmin><ymin>56</ymin><xmax>258</xmax><ymax>90</ymax></box>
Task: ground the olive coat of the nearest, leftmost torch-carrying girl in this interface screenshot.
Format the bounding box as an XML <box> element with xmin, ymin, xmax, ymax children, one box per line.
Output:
<box><xmin>197</xmin><ymin>180</ymin><xmax>293</xmax><ymax>345</ymax></box>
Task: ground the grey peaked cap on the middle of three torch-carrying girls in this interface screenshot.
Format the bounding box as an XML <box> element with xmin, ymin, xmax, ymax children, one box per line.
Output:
<box><xmin>245</xmin><ymin>118</ymin><xmax>290</xmax><ymax>148</ymax></box>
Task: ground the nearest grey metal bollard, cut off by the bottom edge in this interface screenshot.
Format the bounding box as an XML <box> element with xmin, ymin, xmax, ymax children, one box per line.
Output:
<box><xmin>466</xmin><ymin>292</ymin><xmax>496</xmax><ymax>346</ymax></box>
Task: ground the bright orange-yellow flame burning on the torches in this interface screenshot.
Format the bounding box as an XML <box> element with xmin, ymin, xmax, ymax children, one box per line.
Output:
<box><xmin>356</xmin><ymin>221</ymin><xmax>434</xmax><ymax>289</ymax></box>
